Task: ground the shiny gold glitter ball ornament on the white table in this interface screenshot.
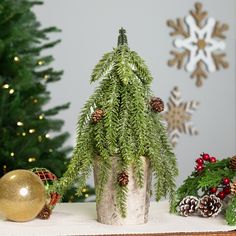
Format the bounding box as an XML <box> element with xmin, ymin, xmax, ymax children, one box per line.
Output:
<box><xmin>0</xmin><ymin>170</ymin><xmax>46</xmax><ymax>222</ymax></box>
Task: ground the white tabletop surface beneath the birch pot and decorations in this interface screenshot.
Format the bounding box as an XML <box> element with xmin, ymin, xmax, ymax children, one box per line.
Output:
<box><xmin>0</xmin><ymin>201</ymin><xmax>236</xmax><ymax>236</ymax></box>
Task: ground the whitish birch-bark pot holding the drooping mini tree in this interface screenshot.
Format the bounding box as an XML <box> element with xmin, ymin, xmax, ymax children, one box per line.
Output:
<box><xmin>94</xmin><ymin>157</ymin><xmax>152</xmax><ymax>225</ymax></box>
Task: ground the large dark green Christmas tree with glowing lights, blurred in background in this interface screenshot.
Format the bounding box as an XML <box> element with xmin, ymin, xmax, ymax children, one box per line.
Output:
<box><xmin>0</xmin><ymin>0</ymin><xmax>70</xmax><ymax>177</ymax></box>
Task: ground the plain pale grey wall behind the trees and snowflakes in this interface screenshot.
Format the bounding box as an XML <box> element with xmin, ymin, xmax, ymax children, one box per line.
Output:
<box><xmin>35</xmin><ymin>0</ymin><xmax>236</xmax><ymax>187</ymax></box>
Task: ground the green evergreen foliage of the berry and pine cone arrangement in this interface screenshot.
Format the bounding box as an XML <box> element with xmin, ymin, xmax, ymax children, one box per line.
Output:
<box><xmin>170</xmin><ymin>154</ymin><xmax>236</xmax><ymax>225</ymax></box>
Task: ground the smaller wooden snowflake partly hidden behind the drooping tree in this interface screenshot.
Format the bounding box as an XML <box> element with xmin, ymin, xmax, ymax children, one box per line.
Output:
<box><xmin>162</xmin><ymin>87</ymin><xmax>199</xmax><ymax>147</ymax></box>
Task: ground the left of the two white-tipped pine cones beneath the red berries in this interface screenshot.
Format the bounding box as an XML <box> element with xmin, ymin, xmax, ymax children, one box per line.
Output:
<box><xmin>179</xmin><ymin>196</ymin><xmax>199</xmax><ymax>216</ymax></box>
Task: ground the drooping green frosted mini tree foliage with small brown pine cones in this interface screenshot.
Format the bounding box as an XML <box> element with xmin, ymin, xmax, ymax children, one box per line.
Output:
<box><xmin>54</xmin><ymin>28</ymin><xmax>177</xmax><ymax>217</ymax></box>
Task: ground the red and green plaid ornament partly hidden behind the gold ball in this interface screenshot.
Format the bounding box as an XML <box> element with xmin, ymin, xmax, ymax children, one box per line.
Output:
<box><xmin>31</xmin><ymin>168</ymin><xmax>61</xmax><ymax>209</ymax></box>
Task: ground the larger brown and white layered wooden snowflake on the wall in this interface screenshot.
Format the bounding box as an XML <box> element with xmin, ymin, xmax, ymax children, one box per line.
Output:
<box><xmin>167</xmin><ymin>3</ymin><xmax>229</xmax><ymax>87</ymax></box>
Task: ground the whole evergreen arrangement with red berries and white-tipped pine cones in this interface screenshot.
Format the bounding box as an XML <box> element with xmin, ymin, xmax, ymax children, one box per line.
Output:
<box><xmin>171</xmin><ymin>153</ymin><xmax>236</xmax><ymax>225</ymax></box>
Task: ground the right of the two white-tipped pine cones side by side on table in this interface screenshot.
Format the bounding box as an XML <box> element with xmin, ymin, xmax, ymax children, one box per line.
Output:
<box><xmin>199</xmin><ymin>194</ymin><xmax>222</xmax><ymax>217</ymax></box>
